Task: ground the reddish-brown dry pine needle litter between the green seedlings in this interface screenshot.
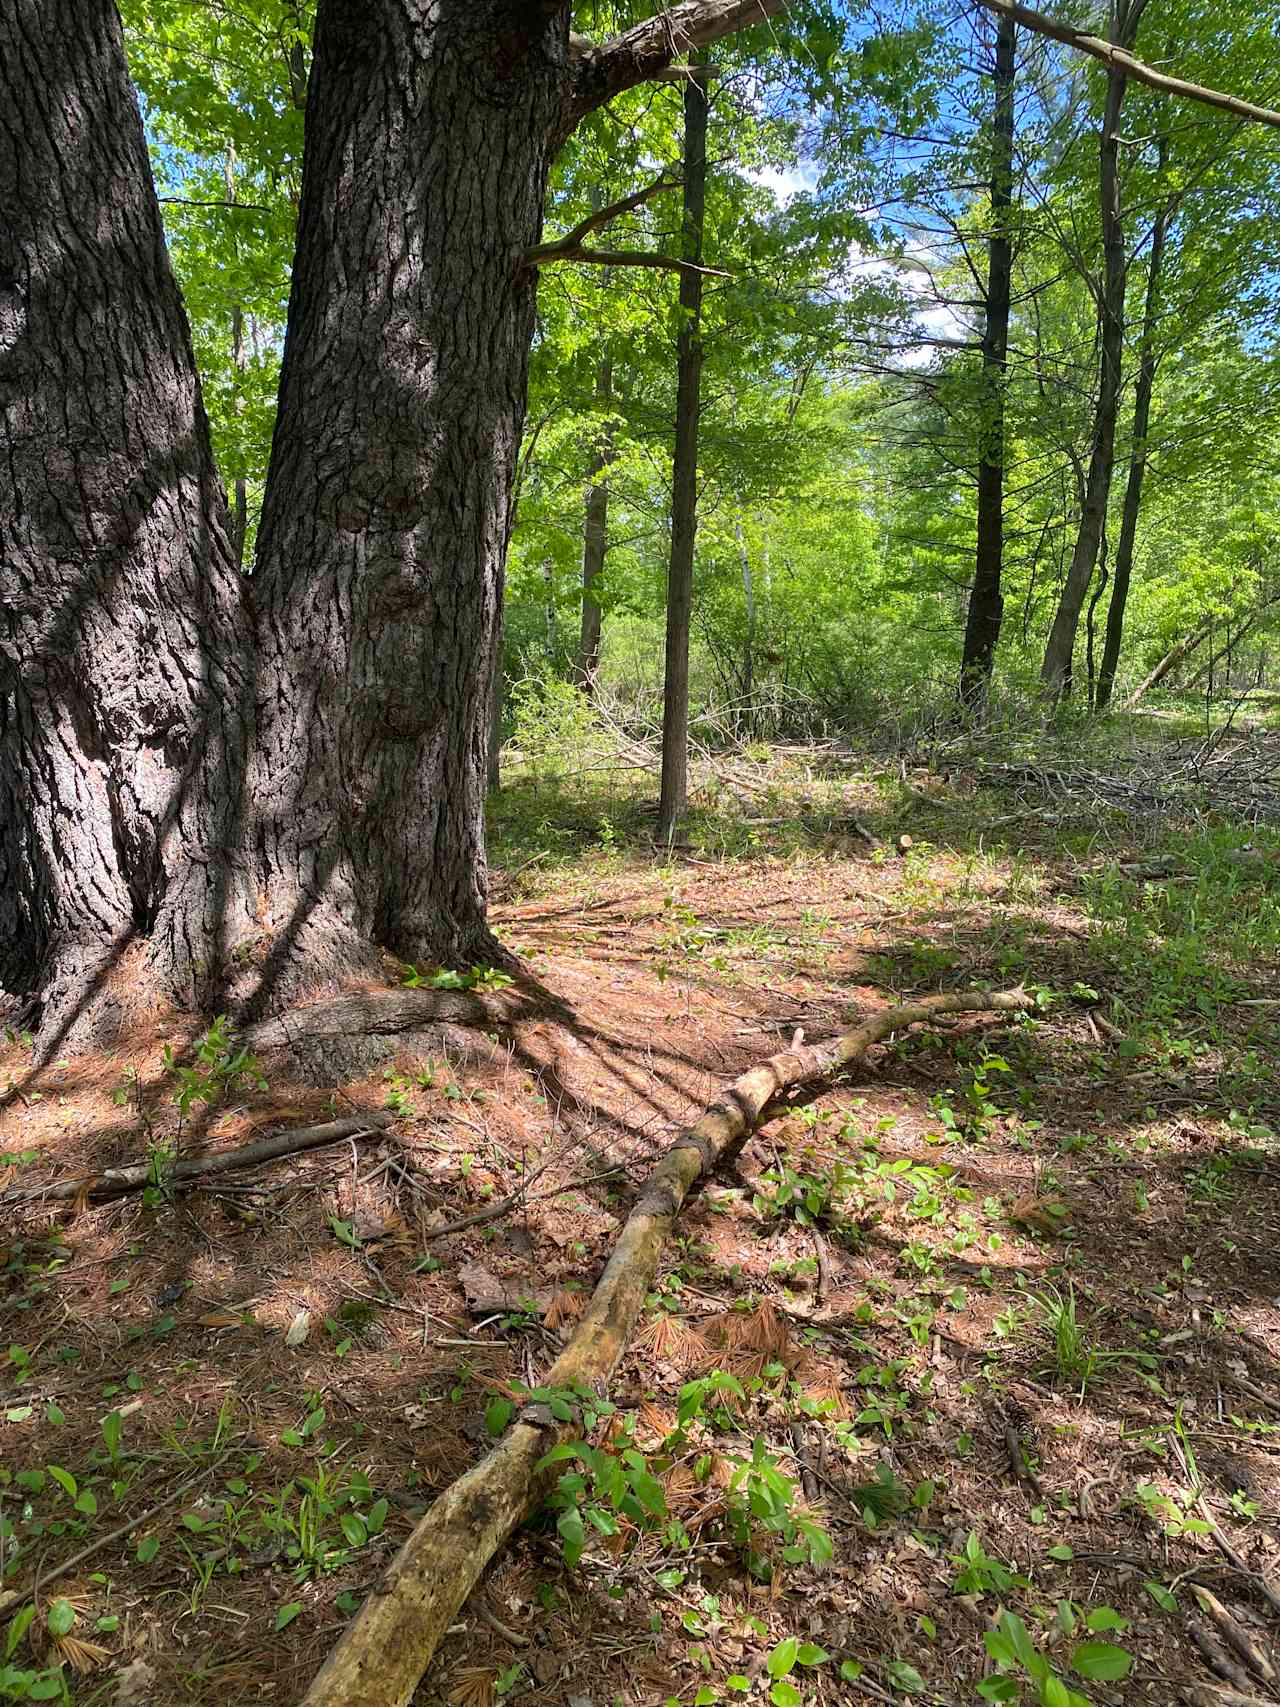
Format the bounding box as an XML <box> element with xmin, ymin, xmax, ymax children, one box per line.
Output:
<box><xmin>0</xmin><ymin>836</ymin><xmax>1280</xmax><ymax>1704</ymax></box>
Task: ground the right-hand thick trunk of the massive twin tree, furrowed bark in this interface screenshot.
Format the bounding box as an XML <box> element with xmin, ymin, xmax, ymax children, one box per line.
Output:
<box><xmin>244</xmin><ymin>0</ymin><xmax>568</xmax><ymax>1004</ymax></box>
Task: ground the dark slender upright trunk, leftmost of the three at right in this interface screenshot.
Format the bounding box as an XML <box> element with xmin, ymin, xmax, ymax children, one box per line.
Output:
<box><xmin>959</xmin><ymin>17</ymin><xmax>1017</xmax><ymax>707</ymax></box>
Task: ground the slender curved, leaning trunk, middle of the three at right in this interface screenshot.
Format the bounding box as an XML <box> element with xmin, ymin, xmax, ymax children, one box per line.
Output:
<box><xmin>1039</xmin><ymin>0</ymin><xmax>1145</xmax><ymax>700</ymax></box>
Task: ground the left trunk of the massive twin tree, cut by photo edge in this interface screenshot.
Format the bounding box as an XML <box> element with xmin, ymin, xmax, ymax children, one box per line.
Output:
<box><xmin>0</xmin><ymin>0</ymin><xmax>251</xmax><ymax>1048</ymax></box>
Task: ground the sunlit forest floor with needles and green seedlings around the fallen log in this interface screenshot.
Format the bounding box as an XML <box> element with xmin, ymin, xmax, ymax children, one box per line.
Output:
<box><xmin>0</xmin><ymin>727</ymin><xmax>1280</xmax><ymax>1707</ymax></box>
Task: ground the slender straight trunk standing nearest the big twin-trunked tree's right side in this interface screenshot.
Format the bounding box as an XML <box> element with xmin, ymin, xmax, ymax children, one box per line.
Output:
<box><xmin>657</xmin><ymin>75</ymin><xmax>707</xmax><ymax>842</ymax></box>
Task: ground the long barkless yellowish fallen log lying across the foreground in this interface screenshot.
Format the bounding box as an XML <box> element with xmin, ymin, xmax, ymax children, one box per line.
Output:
<box><xmin>302</xmin><ymin>990</ymin><xmax>1033</xmax><ymax>1707</ymax></box>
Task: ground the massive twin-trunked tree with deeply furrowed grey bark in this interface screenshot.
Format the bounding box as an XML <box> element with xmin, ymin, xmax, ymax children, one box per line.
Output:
<box><xmin>0</xmin><ymin>0</ymin><xmax>783</xmax><ymax>1040</ymax></box>
